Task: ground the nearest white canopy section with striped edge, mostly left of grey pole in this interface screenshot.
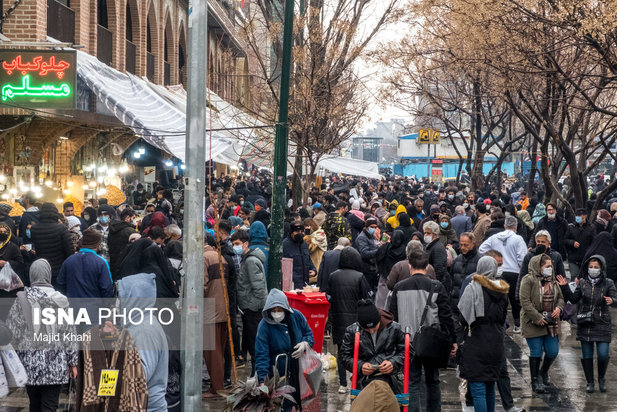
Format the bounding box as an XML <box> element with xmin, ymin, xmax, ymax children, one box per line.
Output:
<box><xmin>77</xmin><ymin>51</ymin><xmax>233</xmax><ymax>161</ymax></box>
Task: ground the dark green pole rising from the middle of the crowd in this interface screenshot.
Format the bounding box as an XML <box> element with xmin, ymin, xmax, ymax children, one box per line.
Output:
<box><xmin>268</xmin><ymin>0</ymin><xmax>294</xmax><ymax>289</ymax></box>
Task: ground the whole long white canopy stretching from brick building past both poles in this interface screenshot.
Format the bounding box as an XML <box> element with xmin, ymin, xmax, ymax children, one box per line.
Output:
<box><xmin>77</xmin><ymin>50</ymin><xmax>381</xmax><ymax>178</ymax></box>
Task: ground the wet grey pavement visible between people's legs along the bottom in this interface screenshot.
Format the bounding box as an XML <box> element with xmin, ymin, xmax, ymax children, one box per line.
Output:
<box><xmin>0</xmin><ymin>309</ymin><xmax>617</xmax><ymax>412</ymax></box>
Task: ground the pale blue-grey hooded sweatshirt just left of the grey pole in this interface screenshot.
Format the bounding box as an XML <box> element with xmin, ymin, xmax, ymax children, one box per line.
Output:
<box><xmin>118</xmin><ymin>273</ymin><xmax>167</xmax><ymax>412</ymax></box>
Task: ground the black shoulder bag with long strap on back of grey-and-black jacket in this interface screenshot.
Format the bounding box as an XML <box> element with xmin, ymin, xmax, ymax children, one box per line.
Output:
<box><xmin>412</xmin><ymin>281</ymin><xmax>452</xmax><ymax>368</ymax></box>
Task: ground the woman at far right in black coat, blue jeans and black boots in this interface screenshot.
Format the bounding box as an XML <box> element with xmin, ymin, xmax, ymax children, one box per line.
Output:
<box><xmin>557</xmin><ymin>255</ymin><xmax>617</xmax><ymax>393</ymax></box>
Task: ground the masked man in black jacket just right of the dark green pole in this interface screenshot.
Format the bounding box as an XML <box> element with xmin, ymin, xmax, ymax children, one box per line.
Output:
<box><xmin>283</xmin><ymin>222</ymin><xmax>317</xmax><ymax>289</ymax></box>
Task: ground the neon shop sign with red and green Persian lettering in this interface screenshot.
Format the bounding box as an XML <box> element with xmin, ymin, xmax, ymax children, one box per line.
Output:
<box><xmin>0</xmin><ymin>49</ymin><xmax>77</xmax><ymax>109</ymax></box>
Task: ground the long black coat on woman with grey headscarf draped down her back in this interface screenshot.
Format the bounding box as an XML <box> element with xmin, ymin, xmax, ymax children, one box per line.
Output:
<box><xmin>459</xmin><ymin>275</ymin><xmax>508</xmax><ymax>382</ymax></box>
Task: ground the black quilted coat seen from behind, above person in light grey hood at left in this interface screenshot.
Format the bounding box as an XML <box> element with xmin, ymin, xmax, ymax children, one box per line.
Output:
<box><xmin>30</xmin><ymin>217</ymin><xmax>75</xmax><ymax>285</ymax></box>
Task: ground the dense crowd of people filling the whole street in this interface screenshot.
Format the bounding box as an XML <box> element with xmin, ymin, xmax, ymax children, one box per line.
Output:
<box><xmin>0</xmin><ymin>171</ymin><xmax>617</xmax><ymax>412</ymax></box>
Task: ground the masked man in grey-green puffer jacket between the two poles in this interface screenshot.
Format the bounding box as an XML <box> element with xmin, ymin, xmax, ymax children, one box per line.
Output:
<box><xmin>231</xmin><ymin>230</ymin><xmax>268</xmax><ymax>371</ymax></box>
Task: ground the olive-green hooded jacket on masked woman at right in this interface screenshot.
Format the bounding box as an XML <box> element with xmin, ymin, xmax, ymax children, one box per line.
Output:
<box><xmin>519</xmin><ymin>255</ymin><xmax>564</xmax><ymax>338</ymax></box>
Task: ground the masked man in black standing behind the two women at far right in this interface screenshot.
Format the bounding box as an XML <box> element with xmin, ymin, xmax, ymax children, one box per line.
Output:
<box><xmin>564</xmin><ymin>209</ymin><xmax>596</xmax><ymax>279</ymax></box>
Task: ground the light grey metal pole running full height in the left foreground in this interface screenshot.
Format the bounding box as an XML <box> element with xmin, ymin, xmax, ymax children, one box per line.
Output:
<box><xmin>181</xmin><ymin>0</ymin><xmax>208</xmax><ymax>412</ymax></box>
